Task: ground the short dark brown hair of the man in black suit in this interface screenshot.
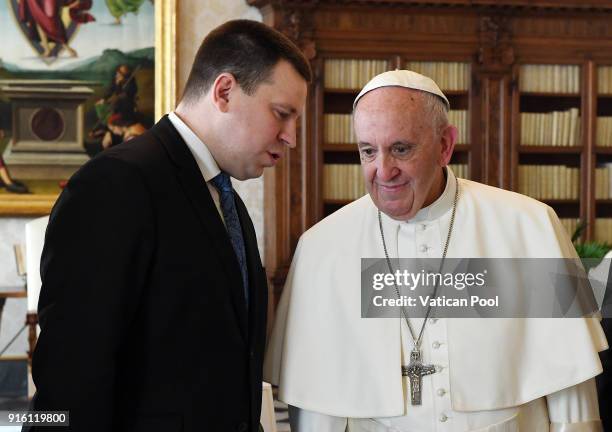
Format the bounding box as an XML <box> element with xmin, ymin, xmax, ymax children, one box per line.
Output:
<box><xmin>183</xmin><ymin>20</ymin><xmax>312</xmax><ymax>100</ymax></box>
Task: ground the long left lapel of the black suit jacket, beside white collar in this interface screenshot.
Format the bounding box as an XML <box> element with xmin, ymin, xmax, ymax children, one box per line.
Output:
<box><xmin>151</xmin><ymin>116</ymin><xmax>248</xmax><ymax>341</ymax></box>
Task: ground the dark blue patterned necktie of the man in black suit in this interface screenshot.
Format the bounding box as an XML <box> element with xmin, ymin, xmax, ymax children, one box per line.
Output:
<box><xmin>211</xmin><ymin>171</ymin><xmax>249</xmax><ymax>308</ymax></box>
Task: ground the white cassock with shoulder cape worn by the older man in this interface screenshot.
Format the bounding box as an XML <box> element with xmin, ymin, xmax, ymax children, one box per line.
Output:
<box><xmin>265</xmin><ymin>169</ymin><xmax>607</xmax><ymax>432</ymax></box>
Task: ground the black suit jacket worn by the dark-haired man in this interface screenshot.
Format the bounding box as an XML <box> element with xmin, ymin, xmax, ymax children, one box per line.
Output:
<box><xmin>23</xmin><ymin>118</ymin><xmax>267</xmax><ymax>432</ymax></box>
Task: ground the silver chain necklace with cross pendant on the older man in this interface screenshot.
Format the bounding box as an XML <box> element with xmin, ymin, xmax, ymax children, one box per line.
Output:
<box><xmin>378</xmin><ymin>177</ymin><xmax>459</xmax><ymax>405</ymax></box>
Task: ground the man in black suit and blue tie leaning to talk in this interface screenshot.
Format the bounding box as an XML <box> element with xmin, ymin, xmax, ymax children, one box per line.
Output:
<box><xmin>24</xmin><ymin>20</ymin><xmax>311</xmax><ymax>432</ymax></box>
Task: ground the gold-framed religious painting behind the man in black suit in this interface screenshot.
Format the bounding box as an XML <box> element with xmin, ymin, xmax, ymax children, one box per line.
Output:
<box><xmin>0</xmin><ymin>0</ymin><xmax>176</xmax><ymax>216</ymax></box>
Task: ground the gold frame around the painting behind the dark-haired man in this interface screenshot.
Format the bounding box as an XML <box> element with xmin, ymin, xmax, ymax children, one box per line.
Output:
<box><xmin>0</xmin><ymin>0</ymin><xmax>177</xmax><ymax>217</ymax></box>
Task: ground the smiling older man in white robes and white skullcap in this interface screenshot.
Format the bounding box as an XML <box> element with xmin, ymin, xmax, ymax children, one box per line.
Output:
<box><xmin>265</xmin><ymin>70</ymin><xmax>608</xmax><ymax>432</ymax></box>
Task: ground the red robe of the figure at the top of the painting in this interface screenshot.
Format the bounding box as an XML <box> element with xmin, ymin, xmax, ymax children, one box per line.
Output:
<box><xmin>19</xmin><ymin>0</ymin><xmax>95</xmax><ymax>44</ymax></box>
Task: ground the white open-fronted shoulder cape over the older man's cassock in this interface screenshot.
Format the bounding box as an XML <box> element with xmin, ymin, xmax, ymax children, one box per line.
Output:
<box><xmin>264</xmin><ymin>174</ymin><xmax>607</xmax><ymax>417</ymax></box>
